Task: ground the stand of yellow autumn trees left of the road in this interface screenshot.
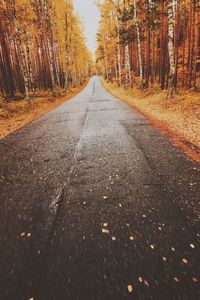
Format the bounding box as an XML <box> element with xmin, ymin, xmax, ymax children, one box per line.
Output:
<box><xmin>0</xmin><ymin>0</ymin><xmax>92</xmax><ymax>98</ymax></box>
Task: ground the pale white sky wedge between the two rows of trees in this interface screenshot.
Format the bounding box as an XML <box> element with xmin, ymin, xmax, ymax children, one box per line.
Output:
<box><xmin>73</xmin><ymin>0</ymin><xmax>99</xmax><ymax>54</ymax></box>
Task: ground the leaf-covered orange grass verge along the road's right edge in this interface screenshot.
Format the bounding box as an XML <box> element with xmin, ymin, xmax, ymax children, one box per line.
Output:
<box><xmin>101</xmin><ymin>78</ymin><xmax>200</xmax><ymax>162</ymax></box>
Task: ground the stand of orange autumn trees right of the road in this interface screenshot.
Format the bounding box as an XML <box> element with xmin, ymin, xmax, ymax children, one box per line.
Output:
<box><xmin>96</xmin><ymin>0</ymin><xmax>200</xmax><ymax>98</ymax></box>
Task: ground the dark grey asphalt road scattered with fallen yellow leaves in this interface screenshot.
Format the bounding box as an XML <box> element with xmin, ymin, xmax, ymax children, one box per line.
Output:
<box><xmin>0</xmin><ymin>77</ymin><xmax>200</xmax><ymax>300</ymax></box>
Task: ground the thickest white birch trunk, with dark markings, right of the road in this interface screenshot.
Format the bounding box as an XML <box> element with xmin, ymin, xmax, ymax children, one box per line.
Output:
<box><xmin>167</xmin><ymin>0</ymin><xmax>176</xmax><ymax>99</ymax></box>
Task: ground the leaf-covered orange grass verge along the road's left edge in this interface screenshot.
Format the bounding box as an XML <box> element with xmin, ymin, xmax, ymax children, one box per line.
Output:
<box><xmin>0</xmin><ymin>80</ymin><xmax>88</xmax><ymax>139</ymax></box>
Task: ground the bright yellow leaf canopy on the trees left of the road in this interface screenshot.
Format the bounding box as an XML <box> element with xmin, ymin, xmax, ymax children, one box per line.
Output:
<box><xmin>13</xmin><ymin>0</ymin><xmax>93</xmax><ymax>78</ymax></box>
